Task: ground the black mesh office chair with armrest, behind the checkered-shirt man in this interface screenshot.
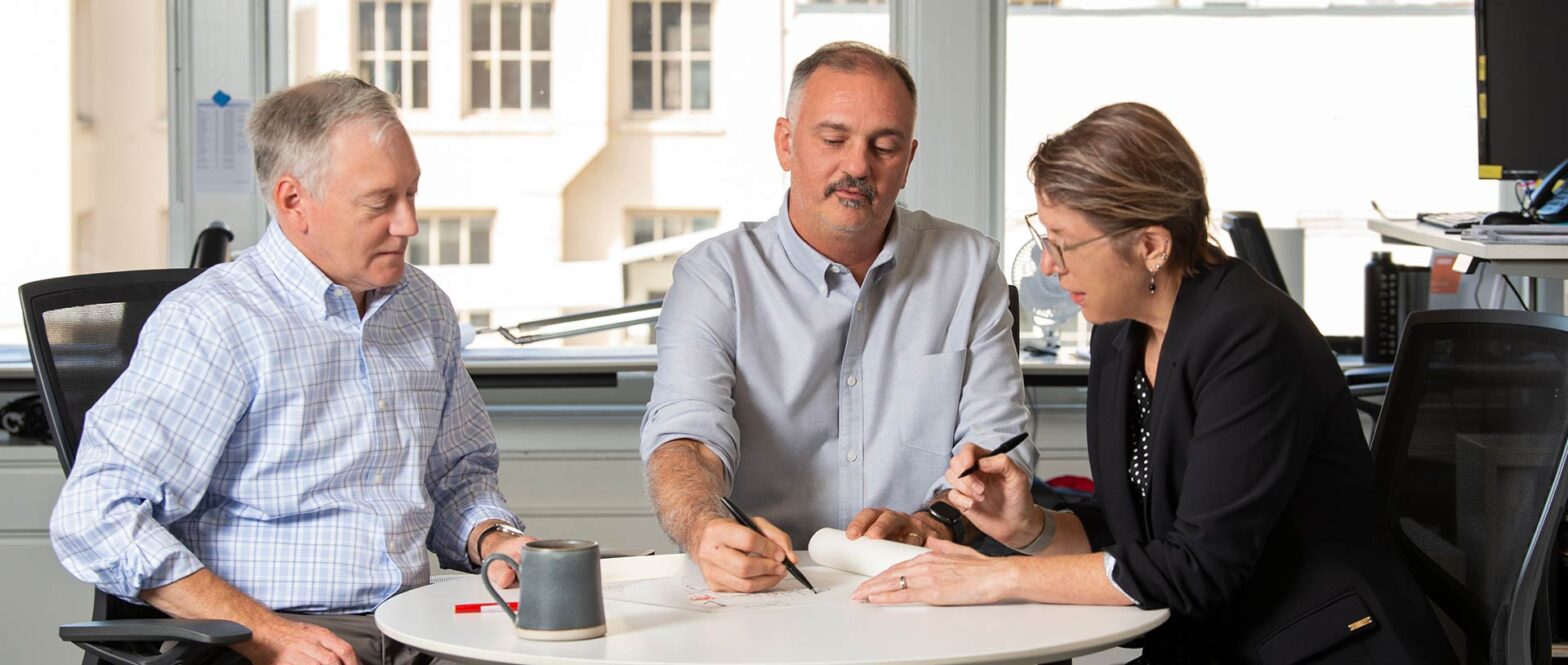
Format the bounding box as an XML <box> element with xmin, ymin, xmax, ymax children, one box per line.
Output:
<box><xmin>22</xmin><ymin>270</ymin><xmax>251</xmax><ymax>665</ymax></box>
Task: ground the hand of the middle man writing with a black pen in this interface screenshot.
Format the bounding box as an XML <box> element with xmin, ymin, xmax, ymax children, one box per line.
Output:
<box><xmin>687</xmin><ymin>518</ymin><xmax>797</xmax><ymax>593</ymax></box>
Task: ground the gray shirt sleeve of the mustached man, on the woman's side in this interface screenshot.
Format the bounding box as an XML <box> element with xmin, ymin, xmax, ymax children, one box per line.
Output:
<box><xmin>931</xmin><ymin>242</ymin><xmax>1040</xmax><ymax>492</ymax></box>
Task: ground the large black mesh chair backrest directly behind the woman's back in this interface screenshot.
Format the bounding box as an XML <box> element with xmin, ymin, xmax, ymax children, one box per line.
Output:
<box><xmin>1372</xmin><ymin>311</ymin><xmax>1568</xmax><ymax>663</ymax></box>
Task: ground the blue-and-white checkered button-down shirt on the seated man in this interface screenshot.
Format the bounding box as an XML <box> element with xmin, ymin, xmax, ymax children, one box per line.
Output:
<box><xmin>50</xmin><ymin>224</ymin><xmax>516</xmax><ymax>613</ymax></box>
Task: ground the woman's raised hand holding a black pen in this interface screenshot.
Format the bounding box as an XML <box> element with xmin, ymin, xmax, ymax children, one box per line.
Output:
<box><xmin>946</xmin><ymin>444</ymin><xmax>1043</xmax><ymax>544</ymax></box>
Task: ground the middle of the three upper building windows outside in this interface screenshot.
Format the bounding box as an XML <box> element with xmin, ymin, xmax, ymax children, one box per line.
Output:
<box><xmin>469</xmin><ymin>0</ymin><xmax>552</xmax><ymax>111</ymax></box>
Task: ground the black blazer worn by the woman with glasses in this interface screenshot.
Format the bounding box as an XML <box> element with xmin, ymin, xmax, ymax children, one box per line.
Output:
<box><xmin>1076</xmin><ymin>260</ymin><xmax>1454</xmax><ymax>663</ymax></box>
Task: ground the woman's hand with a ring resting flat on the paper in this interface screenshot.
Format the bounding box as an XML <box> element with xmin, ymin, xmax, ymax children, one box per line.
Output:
<box><xmin>850</xmin><ymin>540</ymin><xmax>1027</xmax><ymax>605</ymax></box>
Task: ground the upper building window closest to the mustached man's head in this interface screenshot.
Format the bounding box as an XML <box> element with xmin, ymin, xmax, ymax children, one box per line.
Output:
<box><xmin>632</xmin><ymin>0</ymin><xmax>713</xmax><ymax>111</ymax></box>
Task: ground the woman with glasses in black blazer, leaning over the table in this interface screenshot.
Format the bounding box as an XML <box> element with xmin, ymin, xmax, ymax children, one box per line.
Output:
<box><xmin>856</xmin><ymin>104</ymin><xmax>1454</xmax><ymax>663</ymax></box>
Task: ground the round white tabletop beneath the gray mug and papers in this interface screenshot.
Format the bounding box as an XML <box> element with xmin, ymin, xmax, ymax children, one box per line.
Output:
<box><xmin>376</xmin><ymin>552</ymin><xmax>1170</xmax><ymax>665</ymax></box>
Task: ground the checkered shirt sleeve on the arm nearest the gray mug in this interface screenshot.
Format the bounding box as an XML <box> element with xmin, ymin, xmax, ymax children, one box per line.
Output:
<box><xmin>425</xmin><ymin>321</ymin><xmax>522</xmax><ymax>572</ymax></box>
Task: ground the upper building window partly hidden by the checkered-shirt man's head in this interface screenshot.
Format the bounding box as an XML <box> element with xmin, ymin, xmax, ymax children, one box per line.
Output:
<box><xmin>354</xmin><ymin>0</ymin><xmax>430</xmax><ymax>108</ymax></box>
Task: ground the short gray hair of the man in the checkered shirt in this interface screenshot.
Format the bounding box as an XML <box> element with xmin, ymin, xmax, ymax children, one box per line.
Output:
<box><xmin>246</xmin><ymin>74</ymin><xmax>398</xmax><ymax>216</ymax></box>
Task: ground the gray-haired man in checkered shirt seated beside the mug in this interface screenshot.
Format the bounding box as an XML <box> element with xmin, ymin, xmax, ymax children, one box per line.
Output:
<box><xmin>50</xmin><ymin>75</ymin><xmax>532</xmax><ymax>663</ymax></box>
